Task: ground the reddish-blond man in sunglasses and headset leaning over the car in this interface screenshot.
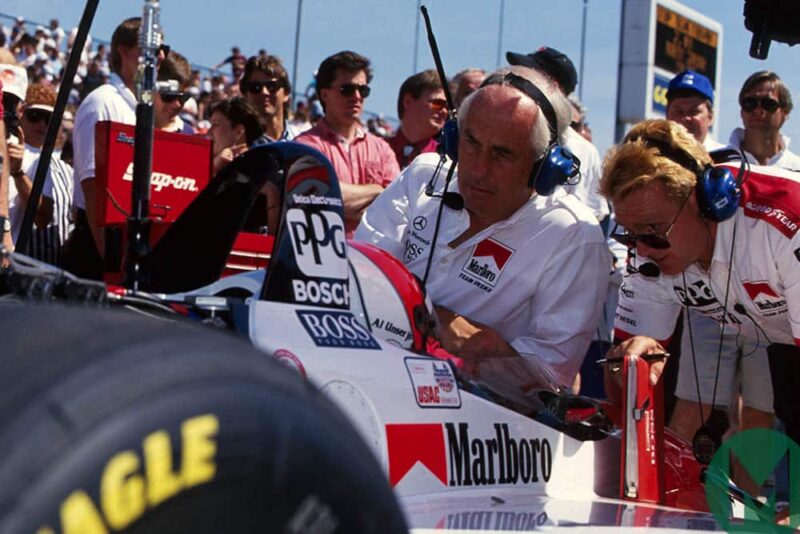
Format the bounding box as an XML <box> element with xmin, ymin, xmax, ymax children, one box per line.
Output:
<box><xmin>601</xmin><ymin>120</ymin><xmax>800</xmax><ymax>450</ymax></box>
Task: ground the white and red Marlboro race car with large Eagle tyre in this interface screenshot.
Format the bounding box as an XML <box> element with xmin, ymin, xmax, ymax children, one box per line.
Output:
<box><xmin>0</xmin><ymin>143</ymin><xmax>768</xmax><ymax>532</ymax></box>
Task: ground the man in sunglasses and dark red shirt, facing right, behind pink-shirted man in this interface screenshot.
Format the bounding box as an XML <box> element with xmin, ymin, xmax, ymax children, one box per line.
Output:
<box><xmin>387</xmin><ymin>69</ymin><xmax>447</xmax><ymax>169</ymax></box>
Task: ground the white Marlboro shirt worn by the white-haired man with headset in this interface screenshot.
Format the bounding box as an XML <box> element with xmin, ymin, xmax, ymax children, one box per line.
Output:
<box><xmin>355</xmin><ymin>153</ymin><xmax>611</xmax><ymax>385</ymax></box>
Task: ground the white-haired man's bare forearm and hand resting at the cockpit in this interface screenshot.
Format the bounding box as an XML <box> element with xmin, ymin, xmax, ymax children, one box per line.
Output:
<box><xmin>436</xmin><ymin>306</ymin><xmax>517</xmax><ymax>361</ymax></box>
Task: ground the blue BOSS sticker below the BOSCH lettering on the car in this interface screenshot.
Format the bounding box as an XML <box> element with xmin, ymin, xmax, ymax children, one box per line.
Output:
<box><xmin>297</xmin><ymin>310</ymin><xmax>381</xmax><ymax>350</ymax></box>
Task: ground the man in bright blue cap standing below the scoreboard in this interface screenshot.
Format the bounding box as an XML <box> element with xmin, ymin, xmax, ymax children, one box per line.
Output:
<box><xmin>667</xmin><ymin>70</ymin><xmax>725</xmax><ymax>152</ymax></box>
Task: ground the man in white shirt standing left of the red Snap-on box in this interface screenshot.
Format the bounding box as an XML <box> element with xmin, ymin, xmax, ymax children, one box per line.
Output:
<box><xmin>64</xmin><ymin>17</ymin><xmax>141</xmax><ymax>279</ymax></box>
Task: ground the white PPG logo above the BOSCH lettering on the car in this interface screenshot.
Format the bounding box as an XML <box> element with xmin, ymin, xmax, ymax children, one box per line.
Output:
<box><xmin>286</xmin><ymin>208</ymin><xmax>347</xmax><ymax>280</ymax></box>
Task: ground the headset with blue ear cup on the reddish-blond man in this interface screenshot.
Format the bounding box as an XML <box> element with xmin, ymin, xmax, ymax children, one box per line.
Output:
<box><xmin>628</xmin><ymin>137</ymin><xmax>747</xmax><ymax>222</ymax></box>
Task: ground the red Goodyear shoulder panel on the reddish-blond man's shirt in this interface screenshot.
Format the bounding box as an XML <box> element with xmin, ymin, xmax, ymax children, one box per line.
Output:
<box><xmin>741</xmin><ymin>167</ymin><xmax>800</xmax><ymax>238</ymax></box>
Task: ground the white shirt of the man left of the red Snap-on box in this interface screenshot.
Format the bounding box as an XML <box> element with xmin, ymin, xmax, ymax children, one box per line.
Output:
<box><xmin>72</xmin><ymin>72</ymin><xmax>136</xmax><ymax>209</ymax></box>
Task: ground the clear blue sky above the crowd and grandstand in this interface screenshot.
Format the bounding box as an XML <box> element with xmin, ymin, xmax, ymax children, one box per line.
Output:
<box><xmin>0</xmin><ymin>0</ymin><xmax>800</xmax><ymax>157</ymax></box>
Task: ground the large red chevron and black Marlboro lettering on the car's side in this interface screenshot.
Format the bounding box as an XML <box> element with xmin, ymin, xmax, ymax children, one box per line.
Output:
<box><xmin>386</xmin><ymin>423</ymin><xmax>553</xmax><ymax>487</ymax></box>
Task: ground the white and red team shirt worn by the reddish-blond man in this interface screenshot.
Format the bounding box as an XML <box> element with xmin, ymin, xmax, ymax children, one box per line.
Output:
<box><xmin>615</xmin><ymin>166</ymin><xmax>800</xmax><ymax>344</ymax></box>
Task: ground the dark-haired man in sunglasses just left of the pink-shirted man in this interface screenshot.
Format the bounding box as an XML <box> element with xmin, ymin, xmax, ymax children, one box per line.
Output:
<box><xmin>239</xmin><ymin>55</ymin><xmax>300</xmax><ymax>145</ymax></box>
